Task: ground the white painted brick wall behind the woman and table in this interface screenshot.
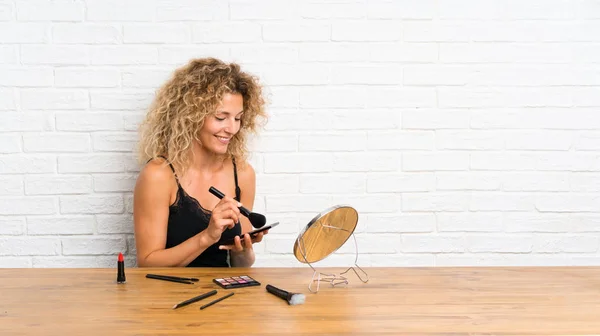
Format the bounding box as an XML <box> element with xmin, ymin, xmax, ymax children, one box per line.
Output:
<box><xmin>0</xmin><ymin>0</ymin><xmax>600</xmax><ymax>267</ymax></box>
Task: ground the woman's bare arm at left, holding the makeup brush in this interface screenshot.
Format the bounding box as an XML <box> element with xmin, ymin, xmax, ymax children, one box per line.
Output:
<box><xmin>133</xmin><ymin>160</ymin><xmax>216</xmax><ymax>267</ymax></box>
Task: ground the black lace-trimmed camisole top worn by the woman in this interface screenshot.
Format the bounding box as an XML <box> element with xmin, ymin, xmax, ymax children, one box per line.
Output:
<box><xmin>166</xmin><ymin>160</ymin><xmax>242</xmax><ymax>267</ymax></box>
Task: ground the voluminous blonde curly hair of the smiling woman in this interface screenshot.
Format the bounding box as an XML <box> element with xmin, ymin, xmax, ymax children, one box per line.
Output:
<box><xmin>138</xmin><ymin>58</ymin><xmax>266</xmax><ymax>173</ymax></box>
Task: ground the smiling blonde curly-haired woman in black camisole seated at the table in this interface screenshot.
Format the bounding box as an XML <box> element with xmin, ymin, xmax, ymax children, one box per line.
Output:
<box><xmin>133</xmin><ymin>58</ymin><xmax>268</xmax><ymax>267</ymax></box>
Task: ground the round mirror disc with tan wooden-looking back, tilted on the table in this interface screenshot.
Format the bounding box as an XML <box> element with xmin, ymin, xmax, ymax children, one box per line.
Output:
<box><xmin>294</xmin><ymin>205</ymin><xmax>358</xmax><ymax>263</ymax></box>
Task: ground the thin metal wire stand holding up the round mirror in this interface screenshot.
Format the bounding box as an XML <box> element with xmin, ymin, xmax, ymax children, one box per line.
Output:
<box><xmin>296</xmin><ymin>224</ymin><xmax>369</xmax><ymax>293</ymax></box>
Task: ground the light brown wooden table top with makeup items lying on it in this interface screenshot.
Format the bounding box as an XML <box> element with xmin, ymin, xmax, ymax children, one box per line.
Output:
<box><xmin>0</xmin><ymin>267</ymin><xmax>600</xmax><ymax>335</ymax></box>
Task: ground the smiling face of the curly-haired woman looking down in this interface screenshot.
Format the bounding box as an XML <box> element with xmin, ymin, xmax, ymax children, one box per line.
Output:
<box><xmin>200</xmin><ymin>93</ymin><xmax>244</xmax><ymax>154</ymax></box>
